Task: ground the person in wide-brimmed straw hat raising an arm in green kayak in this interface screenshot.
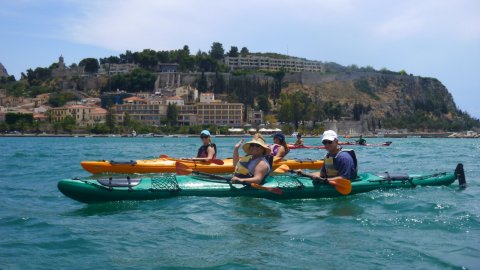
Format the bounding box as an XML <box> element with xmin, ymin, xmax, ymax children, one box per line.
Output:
<box><xmin>232</xmin><ymin>133</ymin><xmax>272</xmax><ymax>184</ymax></box>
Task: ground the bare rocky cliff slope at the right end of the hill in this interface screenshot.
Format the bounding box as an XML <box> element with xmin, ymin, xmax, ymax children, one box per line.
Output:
<box><xmin>282</xmin><ymin>72</ymin><xmax>458</xmax><ymax>120</ymax></box>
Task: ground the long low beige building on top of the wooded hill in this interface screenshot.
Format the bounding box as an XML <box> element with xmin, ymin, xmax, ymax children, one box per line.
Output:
<box><xmin>224</xmin><ymin>55</ymin><xmax>325</xmax><ymax>72</ymax></box>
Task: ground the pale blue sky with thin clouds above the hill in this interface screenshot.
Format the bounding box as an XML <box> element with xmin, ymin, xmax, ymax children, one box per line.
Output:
<box><xmin>0</xmin><ymin>0</ymin><xmax>480</xmax><ymax>118</ymax></box>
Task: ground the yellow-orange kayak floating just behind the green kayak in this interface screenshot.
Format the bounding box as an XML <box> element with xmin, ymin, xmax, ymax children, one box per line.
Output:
<box><xmin>80</xmin><ymin>158</ymin><xmax>323</xmax><ymax>174</ymax></box>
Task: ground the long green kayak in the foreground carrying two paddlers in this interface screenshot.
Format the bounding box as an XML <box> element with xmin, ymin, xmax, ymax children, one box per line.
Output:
<box><xmin>58</xmin><ymin>164</ymin><xmax>465</xmax><ymax>203</ymax></box>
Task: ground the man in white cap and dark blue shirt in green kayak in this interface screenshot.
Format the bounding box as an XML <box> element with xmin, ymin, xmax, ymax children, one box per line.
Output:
<box><xmin>300</xmin><ymin>130</ymin><xmax>357</xmax><ymax>180</ymax></box>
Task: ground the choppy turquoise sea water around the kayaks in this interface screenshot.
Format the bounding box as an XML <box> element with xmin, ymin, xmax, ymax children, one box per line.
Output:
<box><xmin>0</xmin><ymin>138</ymin><xmax>480</xmax><ymax>269</ymax></box>
